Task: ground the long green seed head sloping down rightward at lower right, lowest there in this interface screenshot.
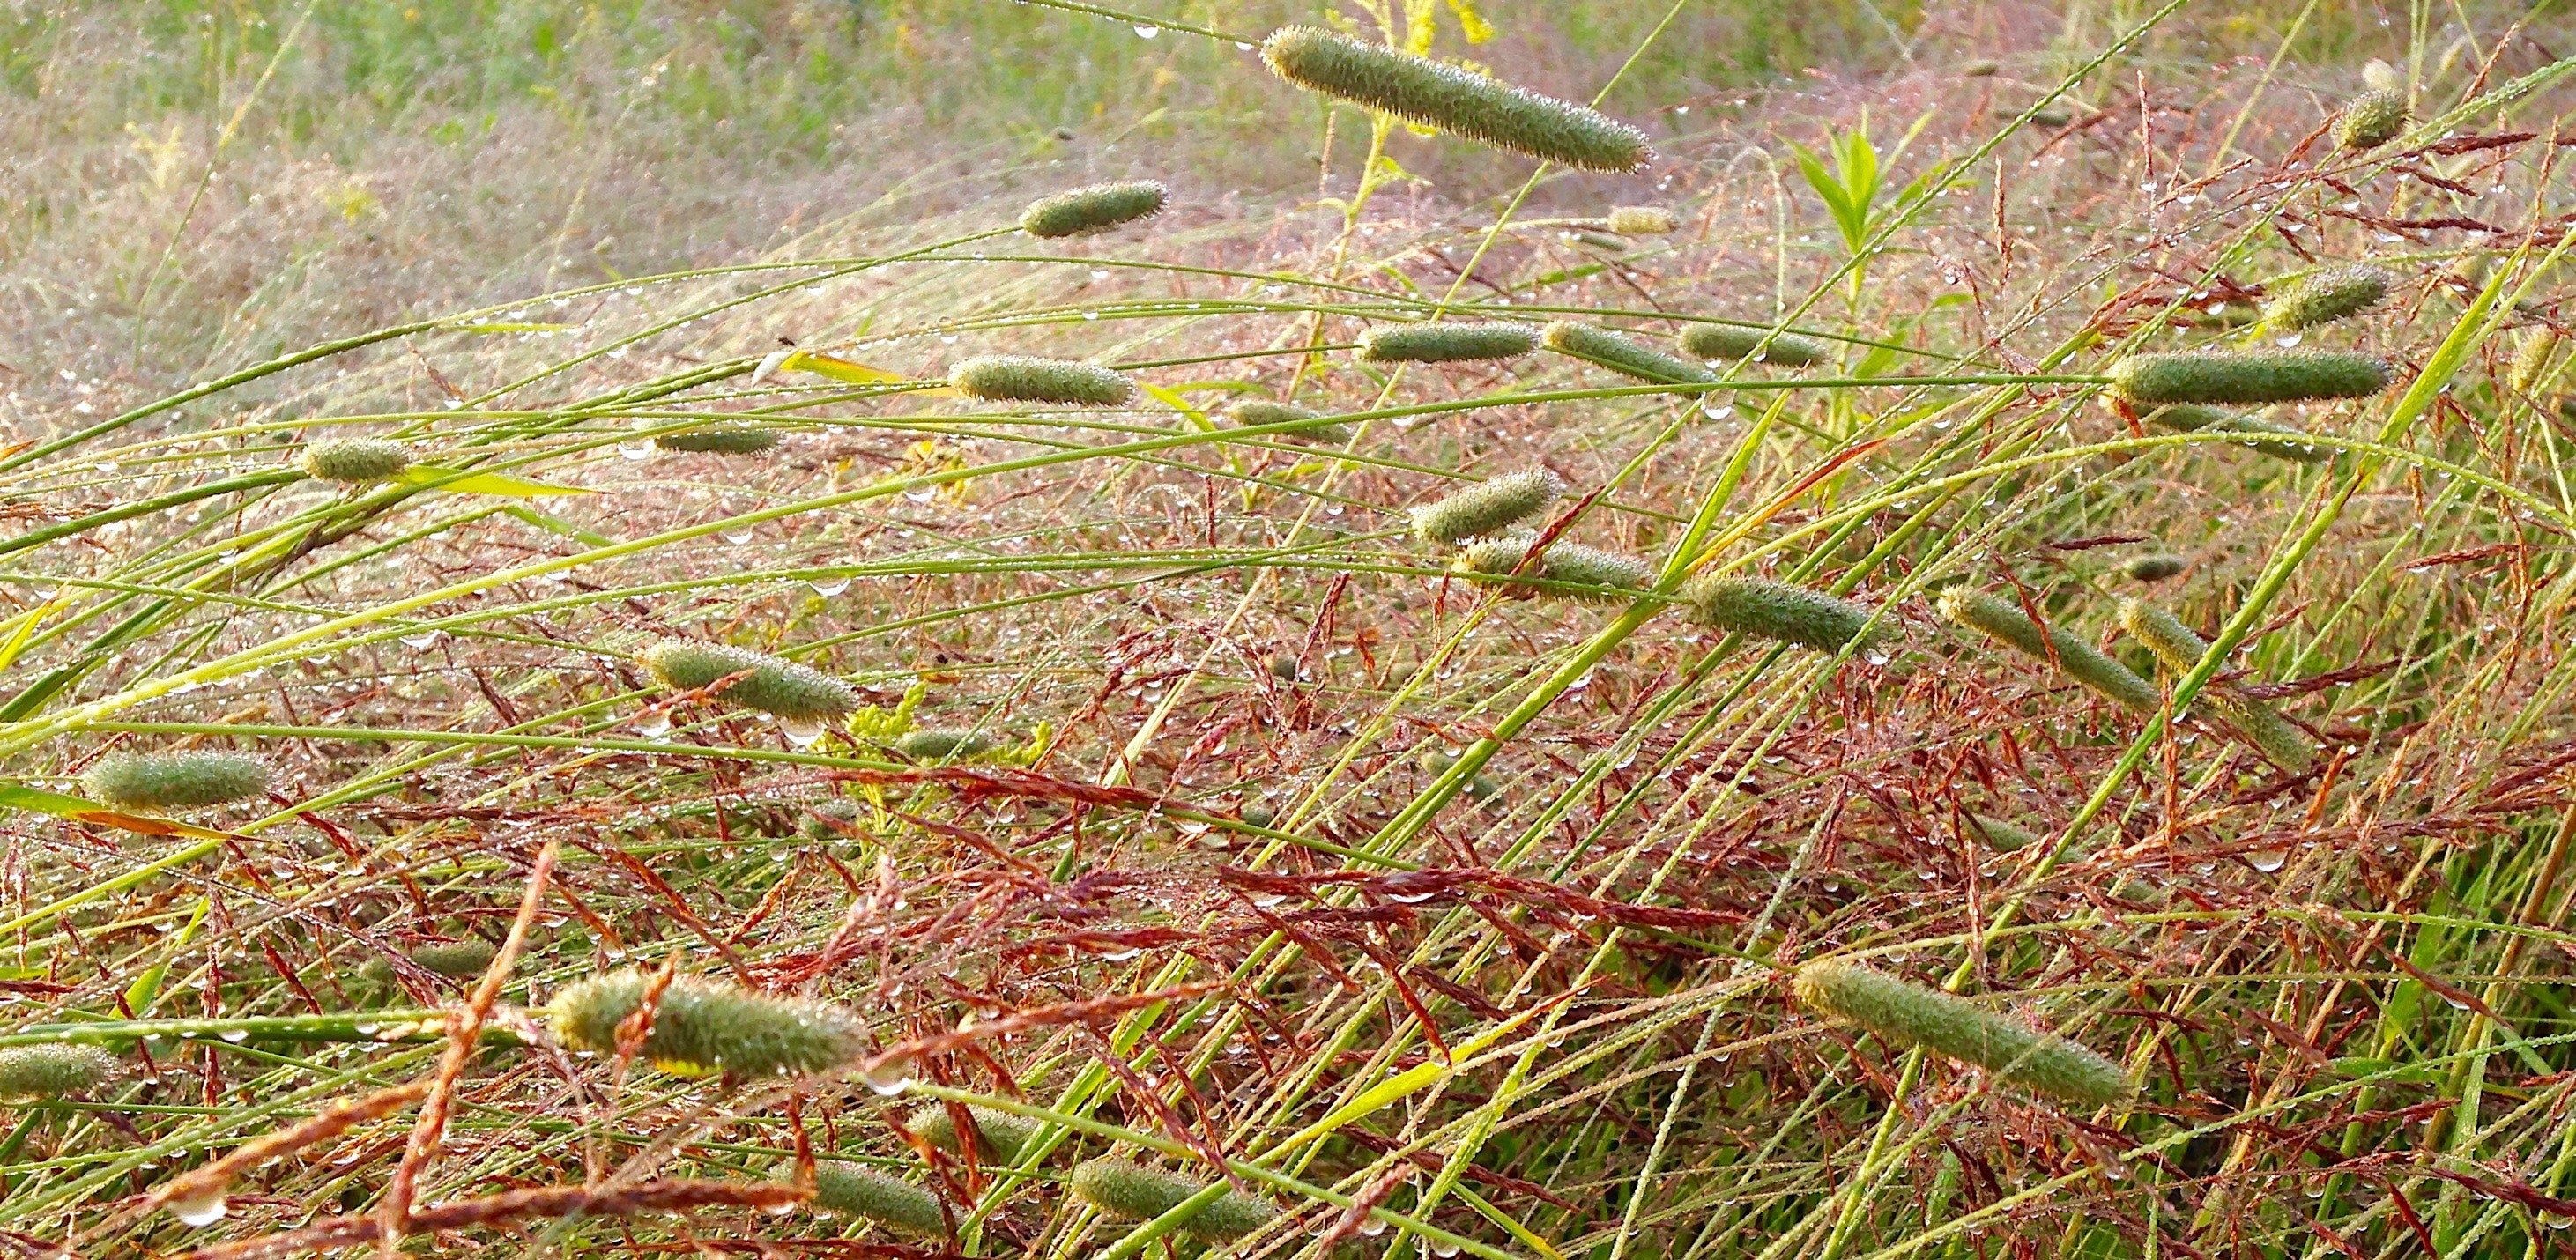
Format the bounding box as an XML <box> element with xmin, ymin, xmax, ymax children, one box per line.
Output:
<box><xmin>1795</xmin><ymin>961</ymin><xmax>2127</xmax><ymax>1108</ymax></box>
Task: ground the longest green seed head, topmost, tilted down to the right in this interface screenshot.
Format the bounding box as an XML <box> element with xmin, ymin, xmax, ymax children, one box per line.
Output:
<box><xmin>1262</xmin><ymin>26</ymin><xmax>1654</xmax><ymax>173</ymax></box>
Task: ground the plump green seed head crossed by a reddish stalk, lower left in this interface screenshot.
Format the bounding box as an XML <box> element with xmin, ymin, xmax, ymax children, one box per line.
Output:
<box><xmin>546</xmin><ymin>969</ymin><xmax>865</xmax><ymax>1077</ymax></box>
